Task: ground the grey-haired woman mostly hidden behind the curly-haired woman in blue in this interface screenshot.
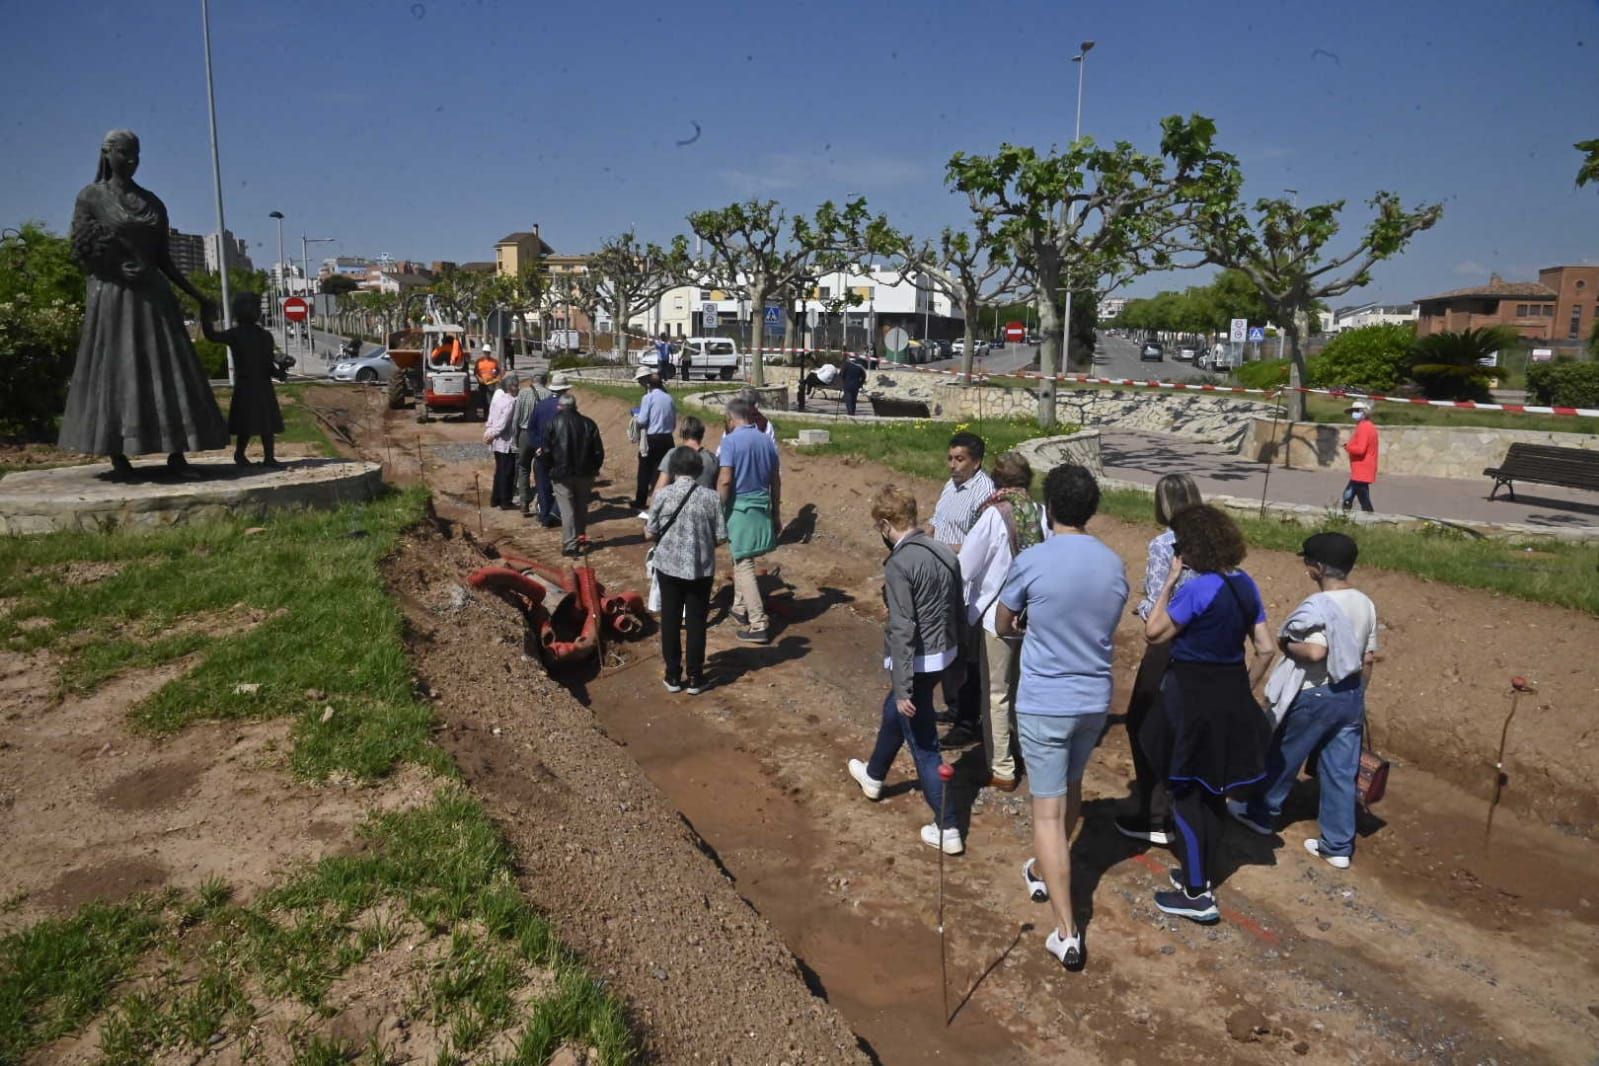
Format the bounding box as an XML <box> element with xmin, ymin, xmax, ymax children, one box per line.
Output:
<box><xmin>1116</xmin><ymin>473</ymin><xmax>1204</xmax><ymax>844</ymax></box>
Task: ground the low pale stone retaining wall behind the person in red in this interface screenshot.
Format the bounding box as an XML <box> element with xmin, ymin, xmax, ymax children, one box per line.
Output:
<box><xmin>1239</xmin><ymin>409</ymin><xmax>1599</xmax><ymax>479</ymax></box>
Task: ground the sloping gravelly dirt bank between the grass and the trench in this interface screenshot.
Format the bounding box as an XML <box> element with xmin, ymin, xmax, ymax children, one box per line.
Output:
<box><xmin>389</xmin><ymin>529</ymin><xmax>868</xmax><ymax>1063</ymax></box>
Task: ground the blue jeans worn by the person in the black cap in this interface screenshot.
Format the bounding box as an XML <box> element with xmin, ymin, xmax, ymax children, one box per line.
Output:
<box><xmin>1249</xmin><ymin>674</ymin><xmax>1366</xmax><ymax>855</ymax></box>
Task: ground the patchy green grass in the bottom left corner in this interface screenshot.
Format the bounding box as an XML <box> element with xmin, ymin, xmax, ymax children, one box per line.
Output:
<box><xmin>0</xmin><ymin>786</ymin><xmax>636</xmax><ymax>1064</ymax></box>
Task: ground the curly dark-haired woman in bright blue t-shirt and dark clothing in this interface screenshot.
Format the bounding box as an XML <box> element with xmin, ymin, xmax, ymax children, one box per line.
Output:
<box><xmin>1140</xmin><ymin>503</ymin><xmax>1274</xmax><ymax>922</ymax></box>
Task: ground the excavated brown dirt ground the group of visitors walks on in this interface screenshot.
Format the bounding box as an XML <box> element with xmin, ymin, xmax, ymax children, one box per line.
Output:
<box><xmin>265</xmin><ymin>390</ymin><xmax>1599</xmax><ymax>1063</ymax></box>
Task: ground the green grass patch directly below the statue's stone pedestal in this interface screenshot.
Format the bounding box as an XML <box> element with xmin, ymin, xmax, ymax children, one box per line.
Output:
<box><xmin>0</xmin><ymin>491</ymin><xmax>448</xmax><ymax>780</ymax></box>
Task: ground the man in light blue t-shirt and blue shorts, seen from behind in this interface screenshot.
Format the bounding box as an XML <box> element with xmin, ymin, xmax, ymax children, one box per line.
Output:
<box><xmin>995</xmin><ymin>463</ymin><xmax>1127</xmax><ymax>969</ymax></box>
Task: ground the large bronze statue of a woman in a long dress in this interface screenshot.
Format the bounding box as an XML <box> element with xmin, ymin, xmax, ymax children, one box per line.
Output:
<box><xmin>59</xmin><ymin>129</ymin><xmax>229</xmax><ymax>478</ymax></box>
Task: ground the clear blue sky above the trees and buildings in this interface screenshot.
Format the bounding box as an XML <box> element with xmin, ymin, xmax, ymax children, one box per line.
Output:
<box><xmin>0</xmin><ymin>0</ymin><xmax>1599</xmax><ymax>300</ymax></box>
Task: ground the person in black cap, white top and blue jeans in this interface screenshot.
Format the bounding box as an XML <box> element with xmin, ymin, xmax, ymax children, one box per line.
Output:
<box><xmin>1226</xmin><ymin>532</ymin><xmax>1377</xmax><ymax>869</ymax></box>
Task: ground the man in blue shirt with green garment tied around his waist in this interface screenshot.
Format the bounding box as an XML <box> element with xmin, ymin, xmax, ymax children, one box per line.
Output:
<box><xmin>716</xmin><ymin>396</ymin><xmax>782</xmax><ymax>644</ymax></box>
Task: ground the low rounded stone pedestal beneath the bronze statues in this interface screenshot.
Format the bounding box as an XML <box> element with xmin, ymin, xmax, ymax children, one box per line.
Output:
<box><xmin>0</xmin><ymin>459</ymin><xmax>384</xmax><ymax>534</ymax></box>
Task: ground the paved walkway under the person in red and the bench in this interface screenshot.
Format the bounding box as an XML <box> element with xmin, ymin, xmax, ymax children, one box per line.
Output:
<box><xmin>1100</xmin><ymin>430</ymin><xmax>1599</xmax><ymax>529</ymax></box>
